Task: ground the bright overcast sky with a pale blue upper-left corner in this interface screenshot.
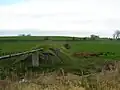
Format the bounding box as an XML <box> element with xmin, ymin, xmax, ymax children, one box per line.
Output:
<box><xmin>0</xmin><ymin>0</ymin><xmax>120</xmax><ymax>37</ymax></box>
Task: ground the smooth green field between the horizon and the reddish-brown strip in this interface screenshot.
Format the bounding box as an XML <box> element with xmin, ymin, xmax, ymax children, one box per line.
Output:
<box><xmin>0</xmin><ymin>36</ymin><xmax>120</xmax><ymax>56</ymax></box>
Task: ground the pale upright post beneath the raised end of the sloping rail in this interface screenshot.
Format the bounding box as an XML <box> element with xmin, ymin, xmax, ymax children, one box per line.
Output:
<box><xmin>32</xmin><ymin>51</ymin><xmax>39</xmax><ymax>67</ymax></box>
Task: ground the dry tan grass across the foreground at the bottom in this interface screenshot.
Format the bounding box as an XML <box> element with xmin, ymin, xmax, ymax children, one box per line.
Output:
<box><xmin>0</xmin><ymin>71</ymin><xmax>120</xmax><ymax>90</ymax></box>
